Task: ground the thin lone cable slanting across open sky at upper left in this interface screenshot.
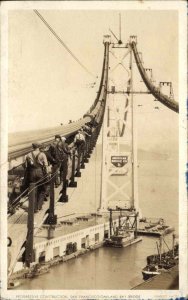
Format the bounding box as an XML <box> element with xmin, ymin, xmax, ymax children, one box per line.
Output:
<box><xmin>33</xmin><ymin>9</ymin><xmax>96</xmax><ymax>77</ymax></box>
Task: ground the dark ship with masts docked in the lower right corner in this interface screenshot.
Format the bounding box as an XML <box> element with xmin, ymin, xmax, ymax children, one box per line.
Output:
<box><xmin>142</xmin><ymin>234</ymin><xmax>179</xmax><ymax>280</ymax></box>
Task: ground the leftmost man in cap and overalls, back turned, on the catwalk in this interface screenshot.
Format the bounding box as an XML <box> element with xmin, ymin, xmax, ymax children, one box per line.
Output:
<box><xmin>25</xmin><ymin>143</ymin><xmax>49</xmax><ymax>212</ymax></box>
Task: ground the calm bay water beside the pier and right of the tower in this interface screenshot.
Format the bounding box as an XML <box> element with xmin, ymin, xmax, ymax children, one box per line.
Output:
<box><xmin>19</xmin><ymin>146</ymin><xmax>178</xmax><ymax>290</ymax></box>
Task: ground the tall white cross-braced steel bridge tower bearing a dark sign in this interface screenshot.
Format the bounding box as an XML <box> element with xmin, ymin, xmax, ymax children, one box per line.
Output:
<box><xmin>99</xmin><ymin>31</ymin><xmax>139</xmax><ymax>212</ymax></box>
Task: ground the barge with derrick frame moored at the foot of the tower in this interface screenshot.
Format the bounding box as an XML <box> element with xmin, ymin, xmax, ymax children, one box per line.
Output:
<box><xmin>104</xmin><ymin>209</ymin><xmax>142</xmax><ymax>248</ymax></box>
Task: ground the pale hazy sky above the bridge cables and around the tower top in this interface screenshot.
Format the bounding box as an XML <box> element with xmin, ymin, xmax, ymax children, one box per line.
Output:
<box><xmin>8</xmin><ymin>9</ymin><xmax>178</xmax><ymax>152</ymax></box>
